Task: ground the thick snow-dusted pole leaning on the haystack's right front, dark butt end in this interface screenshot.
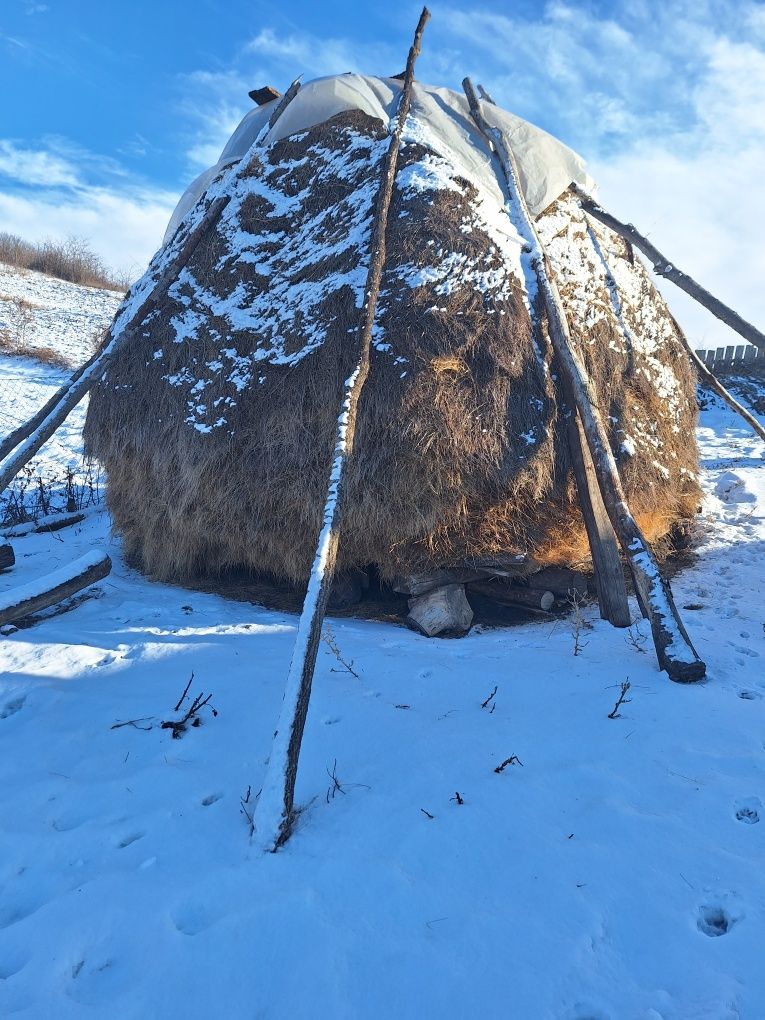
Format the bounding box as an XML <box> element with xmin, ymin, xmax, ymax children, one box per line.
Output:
<box><xmin>463</xmin><ymin>79</ymin><xmax>706</xmax><ymax>682</ymax></box>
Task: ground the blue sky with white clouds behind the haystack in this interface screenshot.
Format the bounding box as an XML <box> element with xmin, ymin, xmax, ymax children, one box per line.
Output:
<box><xmin>0</xmin><ymin>0</ymin><xmax>765</xmax><ymax>343</ymax></box>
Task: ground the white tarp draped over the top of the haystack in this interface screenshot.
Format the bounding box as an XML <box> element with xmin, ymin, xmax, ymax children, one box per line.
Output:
<box><xmin>165</xmin><ymin>73</ymin><xmax>594</xmax><ymax>242</ymax></box>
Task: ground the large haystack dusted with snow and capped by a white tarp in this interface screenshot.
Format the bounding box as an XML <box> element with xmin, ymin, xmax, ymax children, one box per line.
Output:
<box><xmin>86</xmin><ymin>74</ymin><xmax>699</xmax><ymax>595</ymax></box>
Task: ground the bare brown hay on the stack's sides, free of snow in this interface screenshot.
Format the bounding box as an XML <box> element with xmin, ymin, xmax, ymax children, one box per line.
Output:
<box><xmin>86</xmin><ymin>112</ymin><xmax>697</xmax><ymax>581</ymax></box>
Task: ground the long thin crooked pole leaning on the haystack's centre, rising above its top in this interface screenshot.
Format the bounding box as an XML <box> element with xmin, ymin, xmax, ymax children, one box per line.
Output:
<box><xmin>253</xmin><ymin>7</ymin><xmax>430</xmax><ymax>852</ymax></box>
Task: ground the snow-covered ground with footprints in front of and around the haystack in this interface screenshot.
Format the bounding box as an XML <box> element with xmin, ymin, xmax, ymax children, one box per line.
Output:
<box><xmin>0</xmin><ymin>265</ymin><xmax>765</xmax><ymax>1020</ymax></box>
